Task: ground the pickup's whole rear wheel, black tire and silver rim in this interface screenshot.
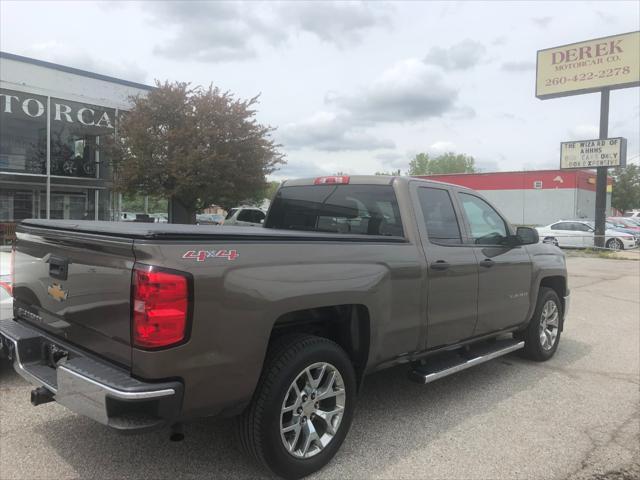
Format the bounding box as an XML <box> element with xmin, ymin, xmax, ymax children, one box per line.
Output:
<box><xmin>238</xmin><ymin>335</ymin><xmax>356</xmax><ymax>479</ymax></box>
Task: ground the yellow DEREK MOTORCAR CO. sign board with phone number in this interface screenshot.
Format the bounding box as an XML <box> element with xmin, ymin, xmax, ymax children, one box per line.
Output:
<box><xmin>536</xmin><ymin>32</ymin><xmax>640</xmax><ymax>100</ymax></box>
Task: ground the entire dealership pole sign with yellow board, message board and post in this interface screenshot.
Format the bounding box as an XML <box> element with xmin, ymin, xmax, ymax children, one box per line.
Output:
<box><xmin>536</xmin><ymin>32</ymin><xmax>640</xmax><ymax>247</ymax></box>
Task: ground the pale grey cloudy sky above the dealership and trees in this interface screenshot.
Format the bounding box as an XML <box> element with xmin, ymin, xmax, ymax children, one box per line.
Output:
<box><xmin>0</xmin><ymin>0</ymin><xmax>640</xmax><ymax>179</ymax></box>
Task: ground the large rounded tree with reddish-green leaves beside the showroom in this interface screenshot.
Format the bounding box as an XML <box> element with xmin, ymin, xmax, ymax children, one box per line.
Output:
<box><xmin>109</xmin><ymin>82</ymin><xmax>284</xmax><ymax>222</ymax></box>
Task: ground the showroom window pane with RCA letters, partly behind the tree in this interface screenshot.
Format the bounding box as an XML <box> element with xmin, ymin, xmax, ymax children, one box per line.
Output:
<box><xmin>50</xmin><ymin>97</ymin><xmax>116</xmax><ymax>178</ymax></box>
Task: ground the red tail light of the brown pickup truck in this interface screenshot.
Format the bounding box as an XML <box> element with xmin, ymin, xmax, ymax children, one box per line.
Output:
<box><xmin>132</xmin><ymin>267</ymin><xmax>190</xmax><ymax>349</ymax></box>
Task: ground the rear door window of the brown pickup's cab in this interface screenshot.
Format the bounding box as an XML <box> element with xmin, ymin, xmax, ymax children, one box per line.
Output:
<box><xmin>418</xmin><ymin>187</ymin><xmax>462</xmax><ymax>244</ymax></box>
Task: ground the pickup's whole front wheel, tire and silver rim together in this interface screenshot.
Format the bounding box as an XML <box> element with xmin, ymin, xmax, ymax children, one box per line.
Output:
<box><xmin>517</xmin><ymin>287</ymin><xmax>563</xmax><ymax>362</ymax></box>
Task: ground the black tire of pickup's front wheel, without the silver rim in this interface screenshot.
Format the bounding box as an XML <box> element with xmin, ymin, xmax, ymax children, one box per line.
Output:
<box><xmin>516</xmin><ymin>287</ymin><xmax>564</xmax><ymax>362</ymax></box>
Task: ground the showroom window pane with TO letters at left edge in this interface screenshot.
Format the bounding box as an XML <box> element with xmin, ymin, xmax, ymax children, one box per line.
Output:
<box><xmin>0</xmin><ymin>89</ymin><xmax>47</xmax><ymax>174</ymax></box>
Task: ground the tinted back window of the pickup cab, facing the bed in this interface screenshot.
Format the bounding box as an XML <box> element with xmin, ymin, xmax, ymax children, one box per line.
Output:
<box><xmin>265</xmin><ymin>185</ymin><xmax>404</xmax><ymax>237</ymax></box>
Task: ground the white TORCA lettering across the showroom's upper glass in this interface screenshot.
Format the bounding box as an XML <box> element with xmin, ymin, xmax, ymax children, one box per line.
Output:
<box><xmin>0</xmin><ymin>93</ymin><xmax>114</xmax><ymax>128</ymax></box>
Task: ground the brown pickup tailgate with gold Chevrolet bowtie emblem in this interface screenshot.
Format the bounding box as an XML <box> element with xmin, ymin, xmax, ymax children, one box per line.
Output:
<box><xmin>14</xmin><ymin>225</ymin><xmax>135</xmax><ymax>367</ymax></box>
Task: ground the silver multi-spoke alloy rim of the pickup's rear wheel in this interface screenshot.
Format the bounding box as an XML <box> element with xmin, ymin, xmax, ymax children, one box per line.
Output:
<box><xmin>280</xmin><ymin>362</ymin><xmax>346</xmax><ymax>458</ymax></box>
